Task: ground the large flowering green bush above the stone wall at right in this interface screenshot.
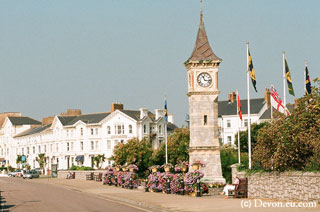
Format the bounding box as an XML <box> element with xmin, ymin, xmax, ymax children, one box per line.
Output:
<box><xmin>253</xmin><ymin>79</ymin><xmax>320</xmax><ymax>171</ymax></box>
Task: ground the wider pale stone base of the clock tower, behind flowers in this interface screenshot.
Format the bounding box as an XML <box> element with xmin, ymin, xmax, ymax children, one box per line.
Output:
<box><xmin>189</xmin><ymin>146</ymin><xmax>226</xmax><ymax>184</ymax></box>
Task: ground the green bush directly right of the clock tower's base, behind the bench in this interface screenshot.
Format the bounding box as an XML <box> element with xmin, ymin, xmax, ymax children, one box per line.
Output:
<box><xmin>220</xmin><ymin>145</ymin><xmax>248</xmax><ymax>183</ymax></box>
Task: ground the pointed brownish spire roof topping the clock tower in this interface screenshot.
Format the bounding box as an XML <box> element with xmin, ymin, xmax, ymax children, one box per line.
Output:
<box><xmin>186</xmin><ymin>12</ymin><xmax>222</xmax><ymax>62</ymax></box>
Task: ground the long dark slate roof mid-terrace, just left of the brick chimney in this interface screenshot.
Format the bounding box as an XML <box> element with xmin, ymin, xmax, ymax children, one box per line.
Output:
<box><xmin>58</xmin><ymin>113</ymin><xmax>110</xmax><ymax>126</ymax></box>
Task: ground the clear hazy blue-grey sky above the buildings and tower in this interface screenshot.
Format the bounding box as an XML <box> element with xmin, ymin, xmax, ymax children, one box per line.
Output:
<box><xmin>0</xmin><ymin>0</ymin><xmax>320</xmax><ymax>126</ymax></box>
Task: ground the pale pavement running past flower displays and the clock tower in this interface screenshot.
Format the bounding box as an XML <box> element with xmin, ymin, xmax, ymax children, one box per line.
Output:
<box><xmin>26</xmin><ymin>178</ymin><xmax>320</xmax><ymax>212</ymax></box>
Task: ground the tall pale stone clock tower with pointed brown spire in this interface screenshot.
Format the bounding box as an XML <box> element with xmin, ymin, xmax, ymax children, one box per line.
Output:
<box><xmin>184</xmin><ymin>11</ymin><xmax>225</xmax><ymax>183</ymax></box>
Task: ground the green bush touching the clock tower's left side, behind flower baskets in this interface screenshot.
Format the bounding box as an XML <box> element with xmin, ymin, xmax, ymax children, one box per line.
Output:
<box><xmin>152</xmin><ymin>128</ymin><xmax>190</xmax><ymax>166</ymax></box>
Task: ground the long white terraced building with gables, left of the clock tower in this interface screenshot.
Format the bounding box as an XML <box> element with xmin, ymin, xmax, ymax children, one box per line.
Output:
<box><xmin>0</xmin><ymin>103</ymin><xmax>178</xmax><ymax>173</ymax></box>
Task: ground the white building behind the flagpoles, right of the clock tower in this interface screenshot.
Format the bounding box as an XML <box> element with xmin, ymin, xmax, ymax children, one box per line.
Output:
<box><xmin>218</xmin><ymin>94</ymin><xmax>271</xmax><ymax>145</ymax></box>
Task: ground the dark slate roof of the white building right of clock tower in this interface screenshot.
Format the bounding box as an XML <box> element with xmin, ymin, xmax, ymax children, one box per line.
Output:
<box><xmin>218</xmin><ymin>98</ymin><xmax>265</xmax><ymax>117</ymax></box>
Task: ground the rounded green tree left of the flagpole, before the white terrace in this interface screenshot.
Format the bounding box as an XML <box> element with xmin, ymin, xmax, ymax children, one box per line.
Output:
<box><xmin>110</xmin><ymin>138</ymin><xmax>152</xmax><ymax>177</ymax></box>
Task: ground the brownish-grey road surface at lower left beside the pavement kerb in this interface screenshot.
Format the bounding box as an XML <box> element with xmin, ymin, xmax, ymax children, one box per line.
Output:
<box><xmin>0</xmin><ymin>178</ymin><xmax>146</xmax><ymax>212</ymax></box>
